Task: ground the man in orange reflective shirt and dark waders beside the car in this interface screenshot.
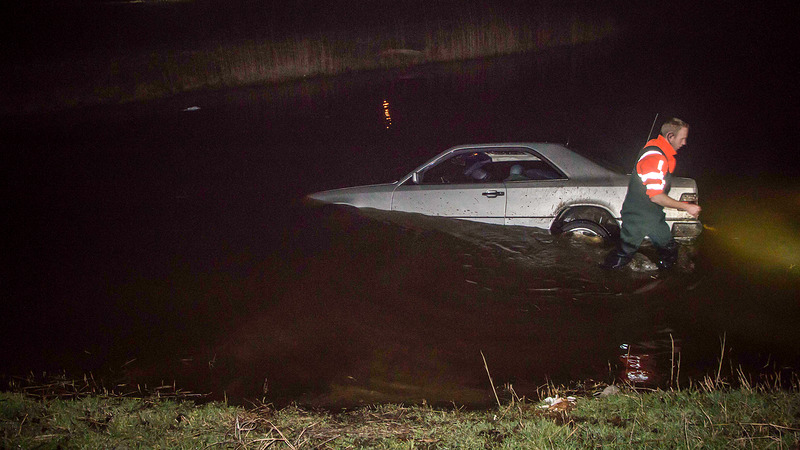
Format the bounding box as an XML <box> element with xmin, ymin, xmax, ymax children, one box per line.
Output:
<box><xmin>601</xmin><ymin>118</ymin><xmax>700</xmax><ymax>270</ymax></box>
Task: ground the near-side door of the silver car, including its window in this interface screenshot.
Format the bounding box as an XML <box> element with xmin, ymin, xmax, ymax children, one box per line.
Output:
<box><xmin>392</xmin><ymin>151</ymin><xmax>506</xmax><ymax>225</ymax></box>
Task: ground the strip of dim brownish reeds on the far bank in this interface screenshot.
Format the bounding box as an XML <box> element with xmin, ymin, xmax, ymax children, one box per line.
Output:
<box><xmin>0</xmin><ymin>8</ymin><xmax>615</xmax><ymax>113</ymax></box>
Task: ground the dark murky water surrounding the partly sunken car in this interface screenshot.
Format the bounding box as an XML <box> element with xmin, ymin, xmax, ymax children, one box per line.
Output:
<box><xmin>0</xmin><ymin>37</ymin><xmax>800</xmax><ymax>406</ymax></box>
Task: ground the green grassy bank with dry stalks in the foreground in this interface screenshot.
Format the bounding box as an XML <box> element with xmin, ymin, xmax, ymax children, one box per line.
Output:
<box><xmin>0</xmin><ymin>388</ymin><xmax>800</xmax><ymax>448</ymax></box>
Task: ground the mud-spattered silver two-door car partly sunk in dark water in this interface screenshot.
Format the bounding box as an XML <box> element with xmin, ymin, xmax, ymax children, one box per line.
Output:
<box><xmin>307</xmin><ymin>143</ymin><xmax>703</xmax><ymax>239</ymax></box>
